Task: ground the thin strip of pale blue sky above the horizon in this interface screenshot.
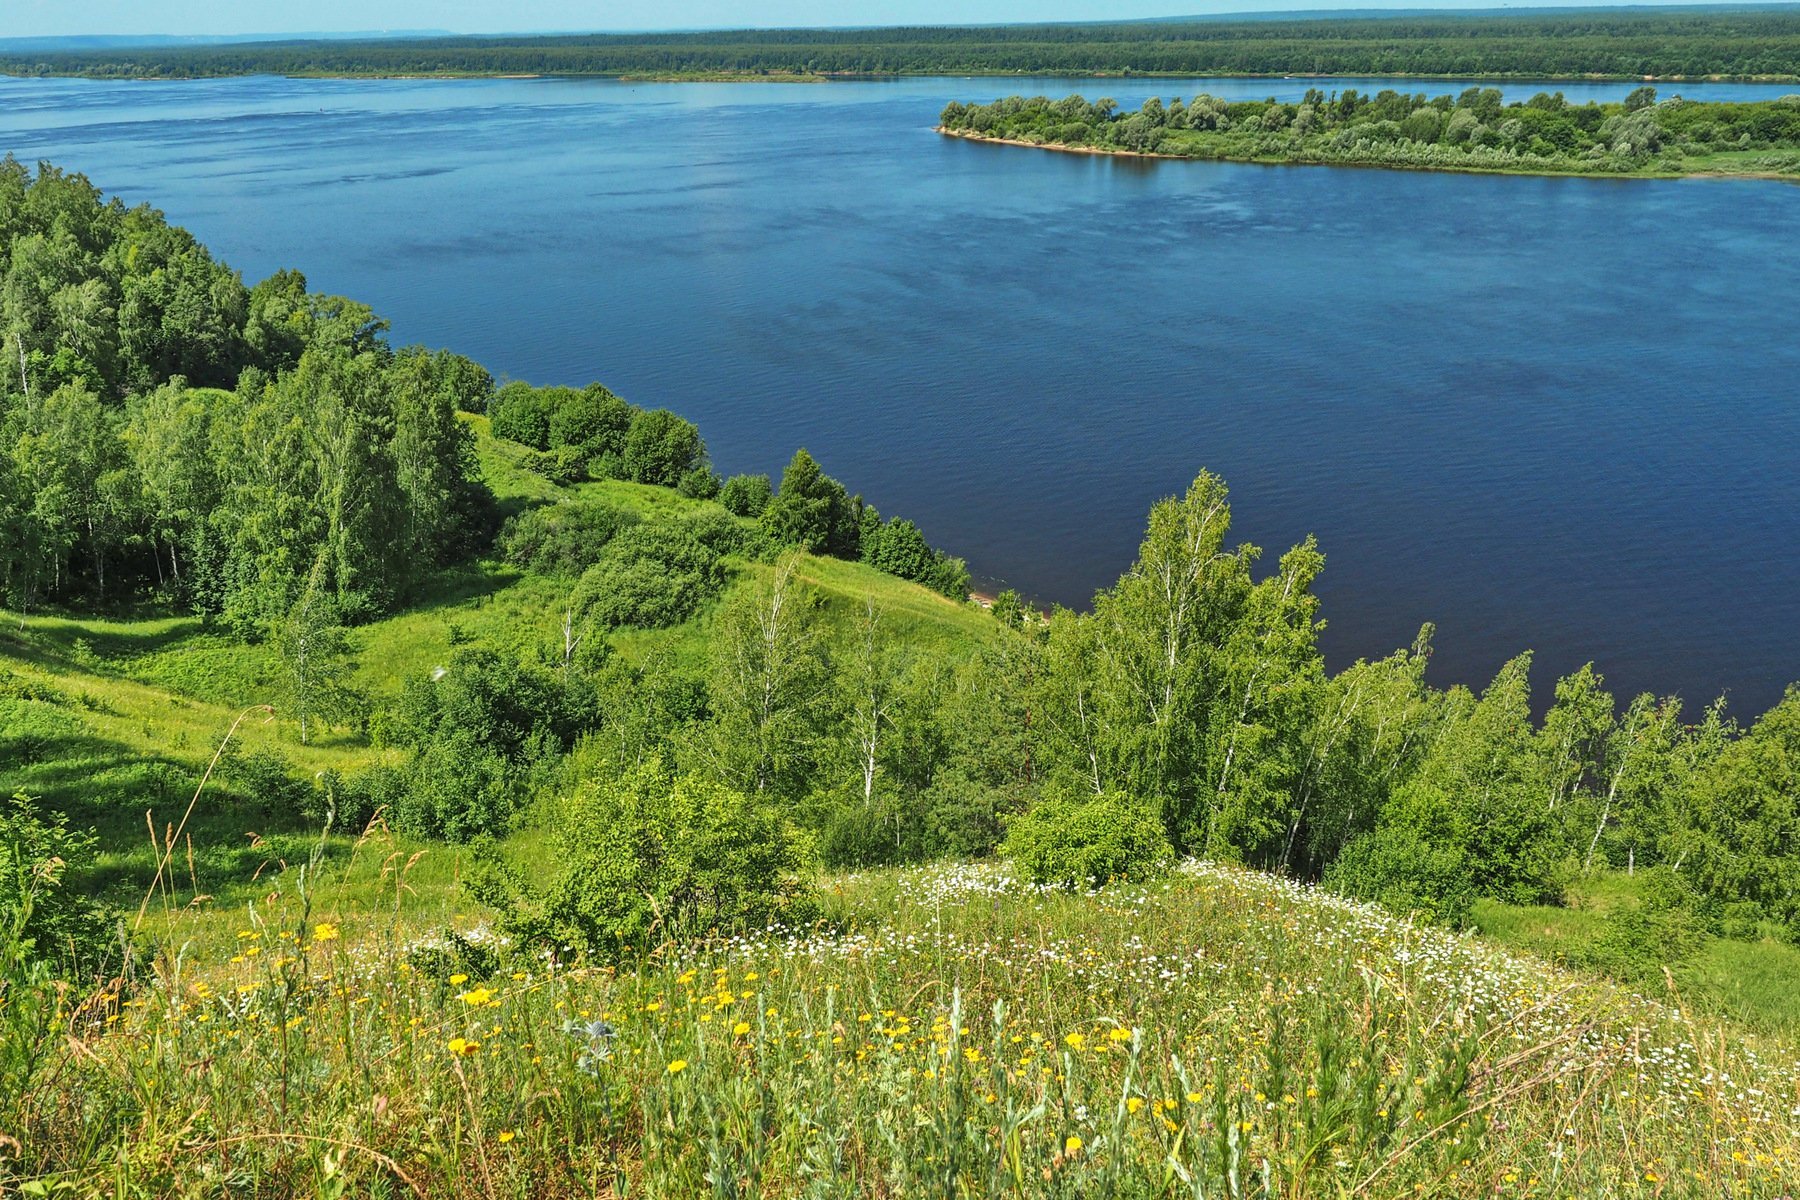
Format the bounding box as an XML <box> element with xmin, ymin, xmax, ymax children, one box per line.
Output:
<box><xmin>0</xmin><ymin>0</ymin><xmax>1713</xmax><ymax>38</ymax></box>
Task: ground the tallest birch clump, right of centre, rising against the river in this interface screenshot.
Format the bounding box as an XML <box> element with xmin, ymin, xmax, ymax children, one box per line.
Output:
<box><xmin>1042</xmin><ymin>473</ymin><xmax>1323</xmax><ymax>862</ymax></box>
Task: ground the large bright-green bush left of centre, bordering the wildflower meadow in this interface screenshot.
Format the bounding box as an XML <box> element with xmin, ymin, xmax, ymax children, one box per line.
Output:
<box><xmin>472</xmin><ymin>763</ymin><xmax>817</xmax><ymax>961</ymax></box>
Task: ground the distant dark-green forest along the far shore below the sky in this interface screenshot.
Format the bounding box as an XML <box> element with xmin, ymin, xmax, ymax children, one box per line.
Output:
<box><xmin>10</xmin><ymin>7</ymin><xmax>1800</xmax><ymax>79</ymax></box>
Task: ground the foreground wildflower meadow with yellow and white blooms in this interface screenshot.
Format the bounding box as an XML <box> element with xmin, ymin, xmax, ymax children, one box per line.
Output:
<box><xmin>13</xmin><ymin>863</ymin><xmax>1800</xmax><ymax>1200</ymax></box>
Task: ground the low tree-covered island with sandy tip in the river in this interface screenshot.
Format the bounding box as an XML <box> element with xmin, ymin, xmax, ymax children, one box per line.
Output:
<box><xmin>938</xmin><ymin>86</ymin><xmax>1800</xmax><ymax>178</ymax></box>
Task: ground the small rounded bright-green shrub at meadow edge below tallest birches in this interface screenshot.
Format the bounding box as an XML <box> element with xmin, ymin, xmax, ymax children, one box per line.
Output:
<box><xmin>1004</xmin><ymin>793</ymin><xmax>1175</xmax><ymax>887</ymax></box>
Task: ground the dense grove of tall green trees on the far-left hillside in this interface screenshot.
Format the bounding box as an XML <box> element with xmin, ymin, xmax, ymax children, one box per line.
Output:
<box><xmin>0</xmin><ymin>160</ymin><xmax>491</xmax><ymax>633</ymax></box>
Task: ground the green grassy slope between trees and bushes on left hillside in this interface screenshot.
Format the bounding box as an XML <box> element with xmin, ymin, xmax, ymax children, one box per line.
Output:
<box><xmin>0</xmin><ymin>417</ymin><xmax>997</xmax><ymax>939</ymax></box>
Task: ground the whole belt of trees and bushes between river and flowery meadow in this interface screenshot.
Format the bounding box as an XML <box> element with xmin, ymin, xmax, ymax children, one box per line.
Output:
<box><xmin>10</xmin><ymin>164</ymin><xmax>1800</xmax><ymax>985</ymax></box>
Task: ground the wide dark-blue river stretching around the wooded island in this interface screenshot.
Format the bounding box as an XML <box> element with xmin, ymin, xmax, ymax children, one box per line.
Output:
<box><xmin>0</xmin><ymin>77</ymin><xmax>1800</xmax><ymax>714</ymax></box>
